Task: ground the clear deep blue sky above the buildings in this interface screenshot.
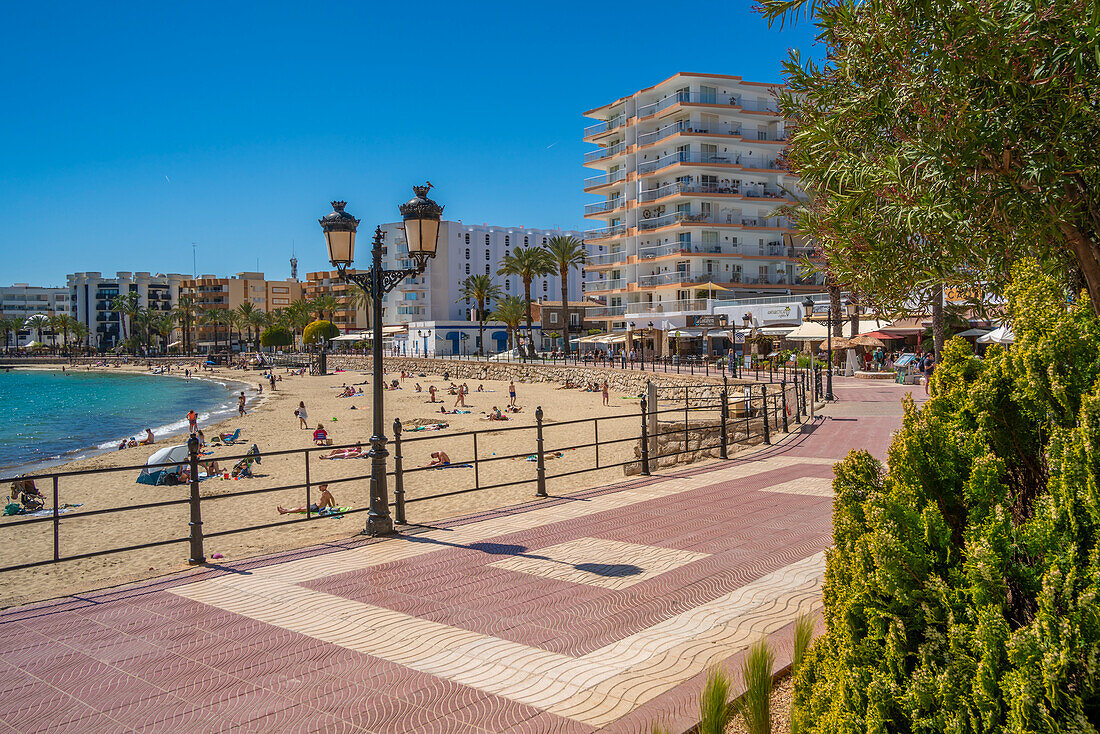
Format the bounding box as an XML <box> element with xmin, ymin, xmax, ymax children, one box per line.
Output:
<box><xmin>0</xmin><ymin>0</ymin><xmax>821</xmax><ymax>285</ymax></box>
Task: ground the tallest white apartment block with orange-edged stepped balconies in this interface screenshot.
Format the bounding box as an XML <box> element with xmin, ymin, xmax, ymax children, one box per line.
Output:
<box><xmin>584</xmin><ymin>73</ymin><xmax>821</xmax><ymax>330</ymax></box>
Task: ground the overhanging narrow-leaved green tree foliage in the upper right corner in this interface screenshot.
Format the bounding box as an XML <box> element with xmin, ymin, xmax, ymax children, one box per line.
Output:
<box><xmin>760</xmin><ymin>0</ymin><xmax>1100</xmax><ymax>308</ymax></box>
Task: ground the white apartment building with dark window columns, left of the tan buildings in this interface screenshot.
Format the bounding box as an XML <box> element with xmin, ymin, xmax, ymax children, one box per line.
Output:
<box><xmin>66</xmin><ymin>272</ymin><xmax>191</xmax><ymax>350</ymax></box>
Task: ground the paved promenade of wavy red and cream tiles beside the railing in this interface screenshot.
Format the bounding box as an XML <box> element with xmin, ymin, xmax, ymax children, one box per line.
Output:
<box><xmin>0</xmin><ymin>380</ymin><xmax>910</xmax><ymax>734</ymax></box>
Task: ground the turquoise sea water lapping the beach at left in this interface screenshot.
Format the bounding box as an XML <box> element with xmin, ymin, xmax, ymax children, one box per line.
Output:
<box><xmin>0</xmin><ymin>370</ymin><xmax>237</xmax><ymax>476</ymax></box>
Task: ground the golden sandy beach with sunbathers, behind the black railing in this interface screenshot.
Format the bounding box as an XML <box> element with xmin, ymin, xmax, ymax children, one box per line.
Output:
<box><xmin>0</xmin><ymin>366</ymin><xmax>739</xmax><ymax>606</ymax></box>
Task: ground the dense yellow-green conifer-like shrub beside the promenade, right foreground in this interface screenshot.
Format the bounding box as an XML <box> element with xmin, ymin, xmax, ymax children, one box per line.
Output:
<box><xmin>793</xmin><ymin>261</ymin><xmax>1100</xmax><ymax>733</ymax></box>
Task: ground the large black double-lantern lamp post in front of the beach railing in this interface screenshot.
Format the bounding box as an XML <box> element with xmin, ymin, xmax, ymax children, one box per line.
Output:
<box><xmin>318</xmin><ymin>185</ymin><xmax>443</xmax><ymax>535</ymax></box>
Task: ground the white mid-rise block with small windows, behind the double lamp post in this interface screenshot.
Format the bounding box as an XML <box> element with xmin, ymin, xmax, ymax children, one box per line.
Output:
<box><xmin>378</xmin><ymin>220</ymin><xmax>584</xmax><ymax>325</ymax></box>
